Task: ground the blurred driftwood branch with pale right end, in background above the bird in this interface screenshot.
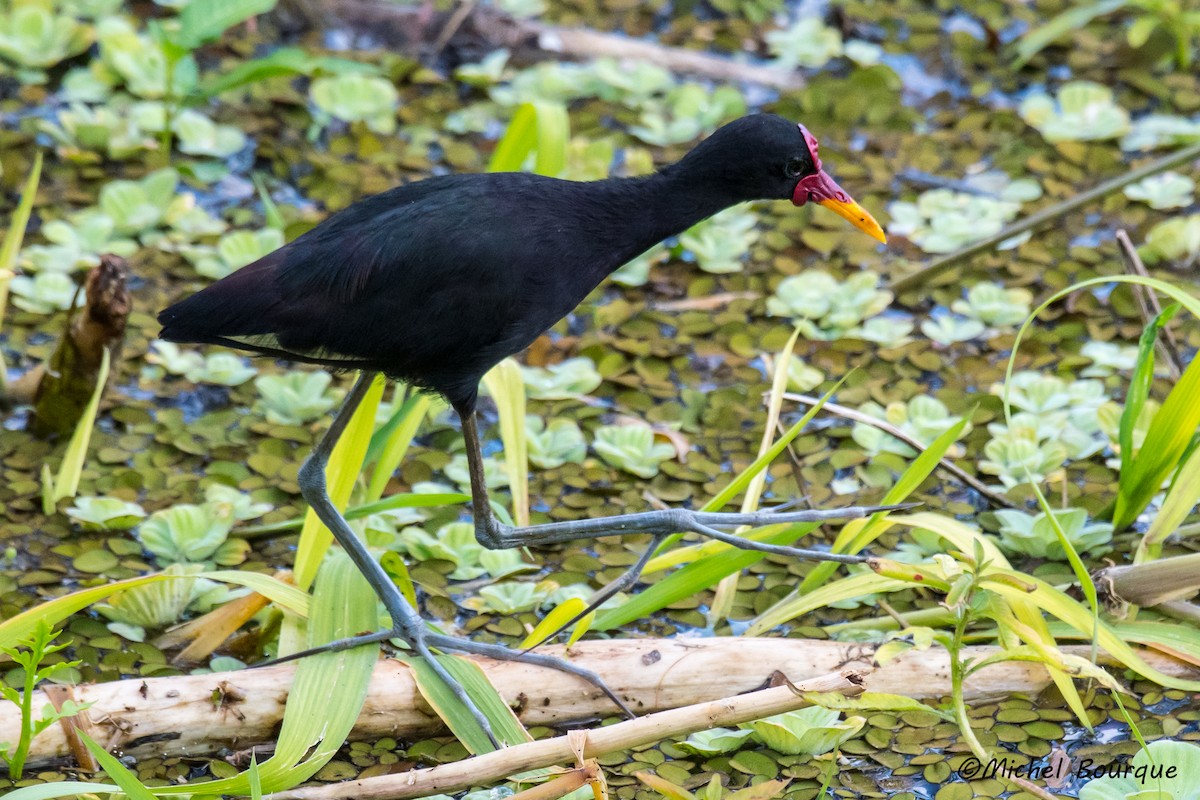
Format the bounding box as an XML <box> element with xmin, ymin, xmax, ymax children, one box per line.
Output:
<box><xmin>314</xmin><ymin>0</ymin><xmax>804</xmax><ymax>89</ymax></box>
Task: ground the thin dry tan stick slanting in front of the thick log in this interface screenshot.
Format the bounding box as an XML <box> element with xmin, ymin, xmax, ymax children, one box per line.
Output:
<box><xmin>268</xmin><ymin>670</ymin><xmax>863</xmax><ymax>800</ymax></box>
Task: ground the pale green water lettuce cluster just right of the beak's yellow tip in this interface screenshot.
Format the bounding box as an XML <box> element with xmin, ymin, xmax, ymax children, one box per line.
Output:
<box><xmin>888</xmin><ymin>188</ymin><xmax>1021</xmax><ymax>253</ymax></box>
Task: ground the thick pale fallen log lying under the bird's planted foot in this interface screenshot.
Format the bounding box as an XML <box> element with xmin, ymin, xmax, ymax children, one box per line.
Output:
<box><xmin>0</xmin><ymin>637</ymin><xmax>1198</xmax><ymax>766</ymax></box>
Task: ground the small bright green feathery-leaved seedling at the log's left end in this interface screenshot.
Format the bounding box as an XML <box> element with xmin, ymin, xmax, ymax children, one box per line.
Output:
<box><xmin>0</xmin><ymin>620</ymin><xmax>91</xmax><ymax>781</ymax></box>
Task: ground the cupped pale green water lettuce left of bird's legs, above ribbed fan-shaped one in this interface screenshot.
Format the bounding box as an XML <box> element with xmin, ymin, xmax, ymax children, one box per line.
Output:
<box><xmin>138</xmin><ymin>503</ymin><xmax>244</xmax><ymax>565</ymax></box>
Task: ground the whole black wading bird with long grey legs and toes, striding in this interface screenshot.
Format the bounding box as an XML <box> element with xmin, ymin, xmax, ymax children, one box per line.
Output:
<box><xmin>158</xmin><ymin>114</ymin><xmax>886</xmax><ymax>741</ymax></box>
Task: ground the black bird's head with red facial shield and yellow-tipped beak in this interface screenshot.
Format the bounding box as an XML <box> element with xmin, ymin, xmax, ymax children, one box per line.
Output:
<box><xmin>700</xmin><ymin>114</ymin><xmax>887</xmax><ymax>242</ymax></box>
